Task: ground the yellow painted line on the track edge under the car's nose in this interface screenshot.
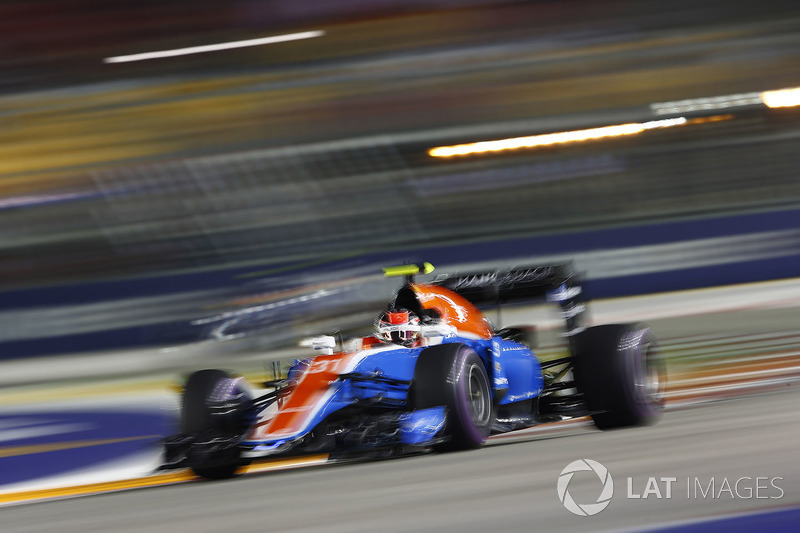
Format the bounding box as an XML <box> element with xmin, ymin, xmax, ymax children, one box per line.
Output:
<box><xmin>0</xmin><ymin>455</ymin><xmax>328</xmax><ymax>505</ymax></box>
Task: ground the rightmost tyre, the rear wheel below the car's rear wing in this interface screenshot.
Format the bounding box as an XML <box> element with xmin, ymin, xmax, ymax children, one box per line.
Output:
<box><xmin>573</xmin><ymin>324</ymin><xmax>667</xmax><ymax>429</ymax></box>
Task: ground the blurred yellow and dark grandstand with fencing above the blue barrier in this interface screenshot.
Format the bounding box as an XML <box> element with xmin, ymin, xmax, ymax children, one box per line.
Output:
<box><xmin>0</xmin><ymin>0</ymin><xmax>800</xmax><ymax>288</ymax></box>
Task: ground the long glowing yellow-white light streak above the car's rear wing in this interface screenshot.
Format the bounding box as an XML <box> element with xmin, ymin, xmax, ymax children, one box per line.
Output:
<box><xmin>428</xmin><ymin>117</ymin><xmax>688</xmax><ymax>157</ymax></box>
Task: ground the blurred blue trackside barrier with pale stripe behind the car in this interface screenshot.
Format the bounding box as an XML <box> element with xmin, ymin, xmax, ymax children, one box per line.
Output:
<box><xmin>0</xmin><ymin>209</ymin><xmax>800</xmax><ymax>359</ymax></box>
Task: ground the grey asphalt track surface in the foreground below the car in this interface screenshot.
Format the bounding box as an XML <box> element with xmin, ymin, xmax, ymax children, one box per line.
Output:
<box><xmin>0</xmin><ymin>386</ymin><xmax>800</xmax><ymax>533</ymax></box>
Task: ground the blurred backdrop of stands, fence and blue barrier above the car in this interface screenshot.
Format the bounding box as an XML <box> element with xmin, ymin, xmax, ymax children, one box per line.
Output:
<box><xmin>0</xmin><ymin>0</ymin><xmax>800</xmax><ymax>358</ymax></box>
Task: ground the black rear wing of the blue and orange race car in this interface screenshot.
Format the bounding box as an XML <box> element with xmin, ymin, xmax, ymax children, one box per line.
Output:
<box><xmin>432</xmin><ymin>263</ymin><xmax>586</xmax><ymax>334</ymax></box>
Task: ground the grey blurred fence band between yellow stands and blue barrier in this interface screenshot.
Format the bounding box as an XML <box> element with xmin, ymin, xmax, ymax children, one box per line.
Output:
<box><xmin>0</xmin><ymin>103</ymin><xmax>800</xmax><ymax>286</ymax></box>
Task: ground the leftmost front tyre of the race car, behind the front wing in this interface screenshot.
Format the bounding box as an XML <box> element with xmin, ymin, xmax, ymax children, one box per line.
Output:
<box><xmin>180</xmin><ymin>369</ymin><xmax>252</xmax><ymax>479</ymax></box>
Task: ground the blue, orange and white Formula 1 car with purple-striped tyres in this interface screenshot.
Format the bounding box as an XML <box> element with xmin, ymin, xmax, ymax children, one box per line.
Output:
<box><xmin>164</xmin><ymin>263</ymin><xmax>666</xmax><ymax>479</ymax></box>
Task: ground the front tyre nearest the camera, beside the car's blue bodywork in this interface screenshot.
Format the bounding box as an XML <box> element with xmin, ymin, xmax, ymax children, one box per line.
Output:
<box><xmin>411</xmin><ymin>343</ymin><xmax>493</xmax><ymax>451</ymax></box>
